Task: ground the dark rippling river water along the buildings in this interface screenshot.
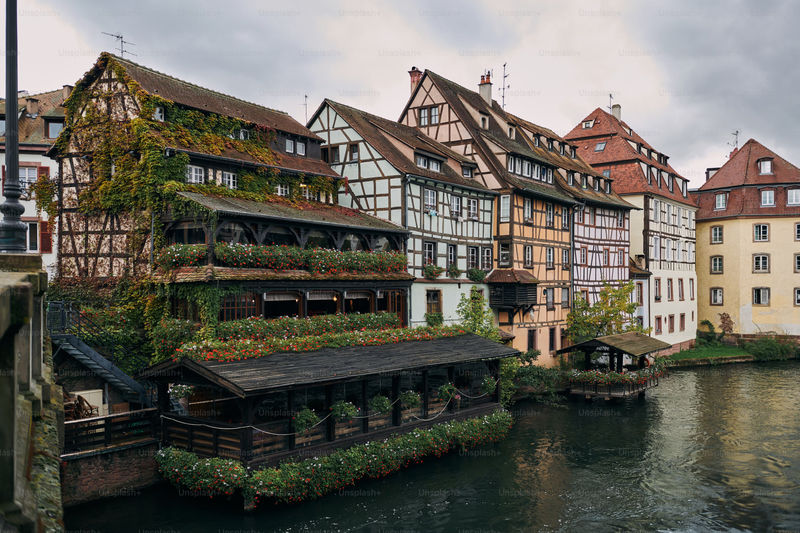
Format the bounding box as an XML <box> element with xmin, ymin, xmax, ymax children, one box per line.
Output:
<box><xmin>66</xmin><ymin>362</ymin><xmax>800</xmax><ymax>533</ymax></box>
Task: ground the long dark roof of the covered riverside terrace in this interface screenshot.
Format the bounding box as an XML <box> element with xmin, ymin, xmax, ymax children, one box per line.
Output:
<box><xmin>143</xmin><ymin>334</ymin><xmax>519</xmax><ymax>397</ymax></box>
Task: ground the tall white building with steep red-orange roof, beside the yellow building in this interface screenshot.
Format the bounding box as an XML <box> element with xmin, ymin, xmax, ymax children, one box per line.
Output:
<box><xmin>565</xmin><ymin>104</ymin><xmax>697</xmax><ymax>349</ymax></box>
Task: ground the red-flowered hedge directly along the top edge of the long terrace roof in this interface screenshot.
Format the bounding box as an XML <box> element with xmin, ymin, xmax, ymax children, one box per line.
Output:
<box><xmin>173</xmin><ymin>326</ymin><xmax>467</xmax><ymax>362</ymax></box>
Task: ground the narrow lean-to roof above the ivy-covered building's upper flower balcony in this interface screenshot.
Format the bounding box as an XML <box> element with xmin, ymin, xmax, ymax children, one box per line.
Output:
<box><xmin>178</xmin><ymin>192</ymin><xmax>407</xmax><ymax>233</ymax></box>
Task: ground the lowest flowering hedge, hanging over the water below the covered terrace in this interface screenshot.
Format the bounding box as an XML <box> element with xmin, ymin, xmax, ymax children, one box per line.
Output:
<box><xmin>156</xmin><ymin>411</ymin><xmax>512</xmax><ymax>504</ymax></box>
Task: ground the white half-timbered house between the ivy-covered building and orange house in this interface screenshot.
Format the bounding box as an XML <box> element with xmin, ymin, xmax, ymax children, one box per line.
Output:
<box><xmin>309</xmin><ymin>100</ymin><xmax>497</xmax><ymax>325</ymax></box>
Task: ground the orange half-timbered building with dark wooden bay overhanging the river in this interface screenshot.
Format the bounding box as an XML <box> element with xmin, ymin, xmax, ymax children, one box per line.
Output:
<box><xmin>400</xmin><ymin>67</ymin><xmax>578</xmax><ymax>365</ymax></box>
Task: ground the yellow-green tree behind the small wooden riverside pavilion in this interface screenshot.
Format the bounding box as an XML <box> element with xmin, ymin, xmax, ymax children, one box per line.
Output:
<box><xmin>565</xmin><ymin>282</ymin><xmax>650</xmax><ymax>343</ymax></box>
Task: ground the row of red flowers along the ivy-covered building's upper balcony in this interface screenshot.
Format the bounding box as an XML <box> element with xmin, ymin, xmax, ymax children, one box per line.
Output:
<box><xmin>214</xmin><ymin>242</ymin><xmax>408</xmax><ymax>274</ymax></box>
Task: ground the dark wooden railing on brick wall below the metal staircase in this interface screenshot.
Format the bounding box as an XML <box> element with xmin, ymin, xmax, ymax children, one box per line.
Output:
<box><xmin>62</xmin><ymin>408</ymin><xmax>160</xmax><ymax>453</ymax></box>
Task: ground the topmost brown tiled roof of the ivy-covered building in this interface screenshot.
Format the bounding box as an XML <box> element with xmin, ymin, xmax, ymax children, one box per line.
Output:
<box><xmin>108</xmin><ymin>52</ymin><xmax>321</xmax><ymax>140</ymax></box>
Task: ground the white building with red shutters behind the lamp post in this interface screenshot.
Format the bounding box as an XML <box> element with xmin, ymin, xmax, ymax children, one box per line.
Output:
<box><xmin>0</xmin><ymin>85</ymin><xmax>72</xmax><ymax>277</ymax></box>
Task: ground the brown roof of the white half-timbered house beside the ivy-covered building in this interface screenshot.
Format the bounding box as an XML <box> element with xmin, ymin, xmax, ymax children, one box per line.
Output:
<box><xmin>322</xmin><ymin>98</ymin><xmax>491</xmax><ymax>192</ymax></box>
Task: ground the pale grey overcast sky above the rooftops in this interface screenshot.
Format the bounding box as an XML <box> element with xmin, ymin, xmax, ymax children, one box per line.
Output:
<box><xmin>3</xmin><ymin>0</ymin><xmax>800</xmax><ymax>186</ymax></box>
